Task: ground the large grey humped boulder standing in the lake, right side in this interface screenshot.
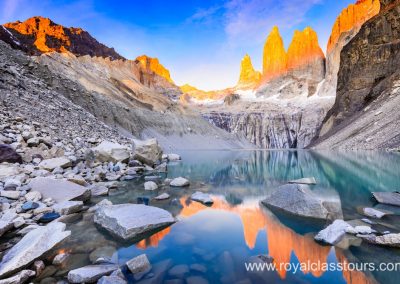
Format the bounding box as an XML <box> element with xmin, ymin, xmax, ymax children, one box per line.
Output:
<box><xmin>262</xmin><ymin>184</ymin><xmax>341</xmax><ymax>219</ymax></box>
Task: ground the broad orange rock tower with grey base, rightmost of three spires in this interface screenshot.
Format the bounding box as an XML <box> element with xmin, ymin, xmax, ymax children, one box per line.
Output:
<box><xmin>287</xmin><ymin>27</ymin><xmax>325</xmax><ymax>80</ymax></box>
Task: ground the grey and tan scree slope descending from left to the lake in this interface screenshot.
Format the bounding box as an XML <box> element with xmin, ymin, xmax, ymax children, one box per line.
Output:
<box><xmin>0</xmin><ymin>17</ymin><xmax>249</xmax><ymax>151</ymax></box>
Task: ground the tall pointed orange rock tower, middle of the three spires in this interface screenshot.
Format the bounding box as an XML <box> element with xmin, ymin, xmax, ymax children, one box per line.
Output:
<box><xmin>262</xmin><ymin>26</ymin><xmax>287</xmax><ymax>81</ymax></box>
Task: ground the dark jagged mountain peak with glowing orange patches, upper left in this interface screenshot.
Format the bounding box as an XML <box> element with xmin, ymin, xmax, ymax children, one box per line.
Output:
<box><xmin>4</xmin><ymin>17</ymin><xmax>124</xmax><ymax>59</ymax></box>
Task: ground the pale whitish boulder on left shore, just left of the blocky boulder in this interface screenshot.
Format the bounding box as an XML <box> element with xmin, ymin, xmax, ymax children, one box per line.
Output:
<box><xmin>93</xmin><ymin>141</ymin><xmax>130</xmax><ymax>163</ymax></box>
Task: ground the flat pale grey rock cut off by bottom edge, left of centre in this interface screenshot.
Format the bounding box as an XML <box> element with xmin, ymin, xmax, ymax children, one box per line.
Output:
<box><xmin>68</xmin><ymin>264</ymin><xmax>118</xmax><ymax>283</ymax></box>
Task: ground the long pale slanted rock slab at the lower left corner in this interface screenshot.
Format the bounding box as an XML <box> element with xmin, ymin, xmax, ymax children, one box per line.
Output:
<box><xmin>0</xmin><ymin>222</ymin><xmax>71</xmax><ymax>277</ymax></box>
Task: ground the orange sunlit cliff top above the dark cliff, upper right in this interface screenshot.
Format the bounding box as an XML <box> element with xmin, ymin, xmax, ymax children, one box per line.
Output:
<box><xmin>327</xmin><ymin>0</ymin><xmax>380</xmax><ymax>52</ymax></box>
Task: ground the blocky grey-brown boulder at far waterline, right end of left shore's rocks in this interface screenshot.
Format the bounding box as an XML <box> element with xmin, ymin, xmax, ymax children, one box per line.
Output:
<box><xmin>133</xmin><ymin>139</ymin><xmax>163</xmax><ymax>166</ymax></box>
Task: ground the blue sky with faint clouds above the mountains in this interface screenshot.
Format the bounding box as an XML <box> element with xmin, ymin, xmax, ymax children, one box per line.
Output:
<box><xmin>0</xmin><ymin>0</ymin><xmax>355</xmax><ymax>90</ymax></box>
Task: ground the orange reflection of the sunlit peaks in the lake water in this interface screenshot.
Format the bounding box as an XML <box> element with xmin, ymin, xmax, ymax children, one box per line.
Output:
<box><xmin>137</xmin><ymin>197</ymin><xmax>372</xmax><ymax>283</ymax></box>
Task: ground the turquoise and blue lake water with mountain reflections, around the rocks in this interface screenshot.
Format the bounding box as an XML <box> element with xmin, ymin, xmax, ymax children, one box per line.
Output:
<box><xmin>37</xmin><ymin>151</ymin><xmax>400</xmax><ymax>283</ymax></box>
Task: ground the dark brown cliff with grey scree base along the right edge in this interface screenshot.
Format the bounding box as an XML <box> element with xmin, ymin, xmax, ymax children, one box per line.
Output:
<box><xmin>316</xmin><ymin>0</ymin><xmax>400</xmax><ymax>149</ymax></box>
